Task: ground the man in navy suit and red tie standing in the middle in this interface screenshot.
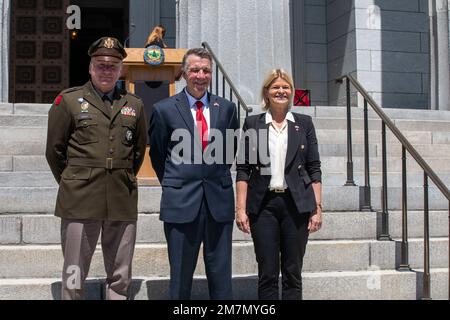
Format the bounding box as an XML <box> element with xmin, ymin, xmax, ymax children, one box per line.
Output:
<box><xmin>149</xmin><ymin>48</ymin><xmax>239</xmax><ymax>299</ymax></box>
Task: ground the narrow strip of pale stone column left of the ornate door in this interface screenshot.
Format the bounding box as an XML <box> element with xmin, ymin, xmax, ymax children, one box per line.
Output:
<box><xmin>0</xmin><ymin>0</ymin><xmax>10</xmax><ymax>102</ymax></box>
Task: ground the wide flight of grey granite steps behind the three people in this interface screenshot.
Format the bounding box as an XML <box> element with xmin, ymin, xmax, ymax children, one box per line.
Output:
<box><xmin>0</xmin><ymin>104</ymin><xmax>450</xmax><ymax>300</ymax></box>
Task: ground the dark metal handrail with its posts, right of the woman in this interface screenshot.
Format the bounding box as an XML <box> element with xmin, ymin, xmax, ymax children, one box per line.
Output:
<box><xmin>336</xmin><ymin>74</ymin><xmax>450</xmax><ymax>300</ymax></box>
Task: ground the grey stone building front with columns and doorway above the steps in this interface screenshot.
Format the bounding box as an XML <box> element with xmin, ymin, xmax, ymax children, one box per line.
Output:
<box><xmin>0</xmin><ymin>0</ymin><xmax>450</xmax><ymax>110</ymax></box>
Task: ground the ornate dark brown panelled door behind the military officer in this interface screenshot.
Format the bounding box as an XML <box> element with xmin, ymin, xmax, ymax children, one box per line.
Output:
<box><xmin>9</xmin><ymin>0</ymin><xmax>70</xmax><ymax>103</ymax></box>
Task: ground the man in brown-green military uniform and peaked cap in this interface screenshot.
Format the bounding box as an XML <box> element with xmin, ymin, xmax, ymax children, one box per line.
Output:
<box><xmin>46</xmin><ymin>37</ymin><xmax>147</xmax><ymax>299</ymax></box>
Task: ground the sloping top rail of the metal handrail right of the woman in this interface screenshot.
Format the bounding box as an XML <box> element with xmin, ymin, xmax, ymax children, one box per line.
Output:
<box><xmin>336</xmin><ymin>75</ymin><xmax>450</xmax><ymax>201</ymax></box>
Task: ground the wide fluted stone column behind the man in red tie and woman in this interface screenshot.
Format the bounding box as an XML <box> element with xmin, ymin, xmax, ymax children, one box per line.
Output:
<box><xmin>177</xmin><ymin>0</ymin><xmax>292</xmax><ymax>104</ymax></box>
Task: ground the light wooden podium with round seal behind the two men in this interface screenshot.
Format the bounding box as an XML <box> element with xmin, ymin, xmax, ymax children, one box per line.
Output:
<box><xmin>121</xmin><ymin>48</ymin><xmax>186</xmax><ymax>185</ymax></box>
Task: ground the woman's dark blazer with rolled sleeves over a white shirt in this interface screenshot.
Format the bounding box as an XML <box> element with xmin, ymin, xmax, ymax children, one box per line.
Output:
<box><xmin>236</xmin><ymin>112</ymin><xmax>322</xmax><ymax>215</ymax></box>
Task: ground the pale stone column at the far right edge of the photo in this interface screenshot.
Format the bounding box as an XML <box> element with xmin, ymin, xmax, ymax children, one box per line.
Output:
<box><xmin>429</xmin><ymin>0</ymin><xmax>450</xmax><ymax>110</ymax></box>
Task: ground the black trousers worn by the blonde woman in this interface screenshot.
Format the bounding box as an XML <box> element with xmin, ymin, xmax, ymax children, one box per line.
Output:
<box><xmin>249</xmin><ymin>191</ymin><xmax>309</xmax><ymax>300</ymax></box>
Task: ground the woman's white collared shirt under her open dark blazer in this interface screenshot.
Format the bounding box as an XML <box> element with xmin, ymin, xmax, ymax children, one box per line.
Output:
<box><xmin>266</xmin><ymin>110</ymin><xmax>295</xmax><ymax>189</ymax></box>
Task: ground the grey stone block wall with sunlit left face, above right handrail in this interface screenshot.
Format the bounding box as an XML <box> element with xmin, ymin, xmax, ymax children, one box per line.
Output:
<box><xmin>354</xmin><ymin>0</ymin><xmax>430</xmax><ymax>109</ymax></box>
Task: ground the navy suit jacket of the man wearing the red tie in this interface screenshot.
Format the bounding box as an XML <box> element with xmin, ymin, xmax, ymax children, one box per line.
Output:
<box><xmin>149</xmin><ymin>90</ymin><xmax>239</xmax><ymax>223</ymax></box>
